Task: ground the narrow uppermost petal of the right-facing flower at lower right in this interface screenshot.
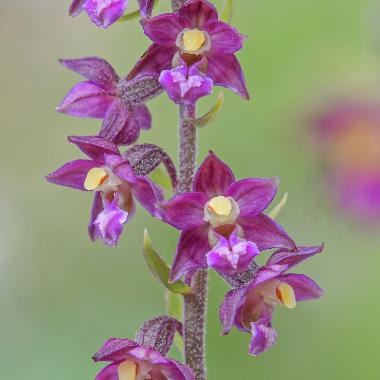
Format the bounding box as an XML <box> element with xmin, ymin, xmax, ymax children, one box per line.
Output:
<box><xmin>266</xmin><ymin>244</ymin><xmax>324</xmax><ymax>270</ymax></box>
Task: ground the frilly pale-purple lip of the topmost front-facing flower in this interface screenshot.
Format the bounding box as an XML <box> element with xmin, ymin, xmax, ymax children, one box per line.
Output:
<box><xmin>159</xmin><ymin>61</ymin><xmax>213</xmax><ymax>104</ymax></box>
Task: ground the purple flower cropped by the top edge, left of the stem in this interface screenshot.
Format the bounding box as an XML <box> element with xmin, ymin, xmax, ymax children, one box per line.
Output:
<box><xmin>69</xmin><ymin>0</ymin><xmax>154</xmax><ymax>28</ymax></box>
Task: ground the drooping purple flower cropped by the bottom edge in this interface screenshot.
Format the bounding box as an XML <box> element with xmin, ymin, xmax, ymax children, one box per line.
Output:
<box><xmin>93</xmin><ymin>338</ymin><xmax>195</xmax><ymax>380</ymax></box>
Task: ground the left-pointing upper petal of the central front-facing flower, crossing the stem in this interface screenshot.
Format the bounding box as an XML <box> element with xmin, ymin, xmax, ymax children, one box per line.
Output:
<box><xmin>160</xmin><ymin>193</ymin><xmax>208</xmax><ymax>231</ymax></box>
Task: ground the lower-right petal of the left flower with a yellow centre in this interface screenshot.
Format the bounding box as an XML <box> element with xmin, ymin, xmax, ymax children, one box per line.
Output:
<box><xmin>131</xmin><ymin>177</ymin><xmax>164</xmax><ymax>217</ymax></box>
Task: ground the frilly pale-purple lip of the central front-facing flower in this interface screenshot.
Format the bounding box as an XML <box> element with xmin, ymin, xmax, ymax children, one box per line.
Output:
<box><xmin>206</xmin><ymin>229</ymin><xmax>260</xmax><ymax>275</ymax></box>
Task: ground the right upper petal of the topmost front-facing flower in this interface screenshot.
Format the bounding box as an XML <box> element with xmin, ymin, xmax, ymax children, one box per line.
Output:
<box><xmin>203</xmin><ymin>21</ymin><xmax>245</xmax><ymax>54</ymax></box>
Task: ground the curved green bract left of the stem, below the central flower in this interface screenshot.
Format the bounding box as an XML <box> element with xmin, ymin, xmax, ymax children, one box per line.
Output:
<box><xmin>144</xmin><ymin>230</ymin><xmax>191</xmax><ymax>294</ymax></box>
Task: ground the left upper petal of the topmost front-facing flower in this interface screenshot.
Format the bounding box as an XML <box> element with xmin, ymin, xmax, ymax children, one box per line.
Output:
<box><xmin>141</xmin><ymin>13</ymin><xmax>183</xmax><ymax>47</ymax></box>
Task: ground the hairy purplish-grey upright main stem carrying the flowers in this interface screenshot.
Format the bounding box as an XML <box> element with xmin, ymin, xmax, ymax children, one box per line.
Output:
<box><xmin>179</xmin><ymin>105</ymin><xmax>208</xmax><ymax>380</ymax></box>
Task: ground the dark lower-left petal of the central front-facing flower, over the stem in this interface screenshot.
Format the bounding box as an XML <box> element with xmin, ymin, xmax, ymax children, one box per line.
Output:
<box><xmin>170</xmin><ymin>225</ymin><xmax>210</xmax><ymax>282</ymax></box>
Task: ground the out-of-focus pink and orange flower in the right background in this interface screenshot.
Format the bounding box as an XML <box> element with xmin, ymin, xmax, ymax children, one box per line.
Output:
<box><xmin>314</xmin><ymin>102</ymin><xmax>380</xmax><ymax>221</ymax></box>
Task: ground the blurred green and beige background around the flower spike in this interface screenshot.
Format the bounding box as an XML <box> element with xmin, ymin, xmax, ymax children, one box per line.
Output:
<box><xmin>0</xmin><ymin>0</ymin><xmax>380</xmax><ymax>380</ymax></box>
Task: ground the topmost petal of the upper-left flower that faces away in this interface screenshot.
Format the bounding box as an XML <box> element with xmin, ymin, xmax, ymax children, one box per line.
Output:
<box><xmin>59</xmin><ymin>57</ymin><xmax>119</xmax><ymax>88</ymax></box>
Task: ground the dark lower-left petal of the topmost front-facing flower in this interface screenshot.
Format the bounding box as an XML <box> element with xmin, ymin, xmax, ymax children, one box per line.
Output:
<box><xmin>128</xmin><ymin>44</ymin><xmax>177</xmax><ymax>80</ymax></box>
